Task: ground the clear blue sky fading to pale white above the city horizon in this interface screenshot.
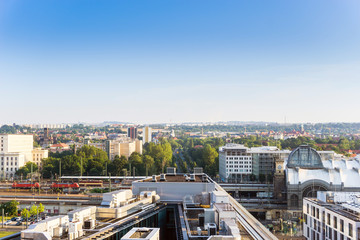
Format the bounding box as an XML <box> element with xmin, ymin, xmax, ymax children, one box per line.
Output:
<box><xmin>0</xmin><ymin>0</ymin><xmax>360</xmax><ymax>124</ymax></box>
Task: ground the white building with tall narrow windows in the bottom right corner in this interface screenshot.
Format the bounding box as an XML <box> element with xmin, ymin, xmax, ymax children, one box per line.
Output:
<box><xmin>302</xmin><ymin>192</ymin><xmax>360</xmax><ymax>240</ymax></box>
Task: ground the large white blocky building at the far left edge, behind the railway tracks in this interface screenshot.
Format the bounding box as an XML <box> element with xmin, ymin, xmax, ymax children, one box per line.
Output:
<box><xmin>0</xmin><ymin>134</ymin><xmax>34</xmax><ymax>178</ymax></box>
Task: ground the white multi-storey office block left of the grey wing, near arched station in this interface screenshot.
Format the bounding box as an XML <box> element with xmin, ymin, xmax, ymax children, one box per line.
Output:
<box><xmin>219</xmin><ymin>143</ymin><xmax>252</xmax><ymax>182</ymax></box>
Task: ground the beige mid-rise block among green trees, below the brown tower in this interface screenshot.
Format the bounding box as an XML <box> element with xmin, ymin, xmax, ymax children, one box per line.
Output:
<box><xmin>105</xmin><ymin>139</ymin><xmax>142</xmax><ymax>160</ymax></box>
